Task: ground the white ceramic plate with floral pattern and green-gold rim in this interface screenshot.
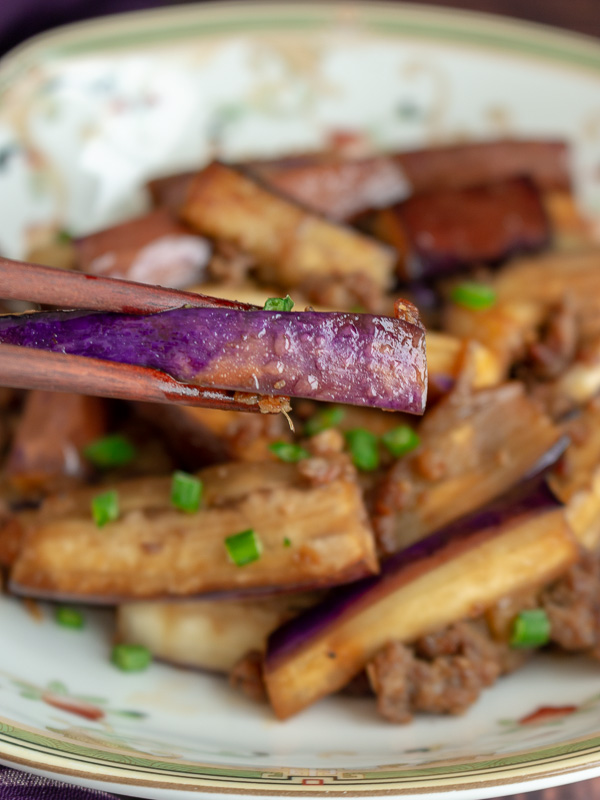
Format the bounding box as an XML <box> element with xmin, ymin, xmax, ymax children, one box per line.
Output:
<box><xmin>0</xmin><ymin>2</ymin><xmax>600</xmax><ymax>800</ymax></box>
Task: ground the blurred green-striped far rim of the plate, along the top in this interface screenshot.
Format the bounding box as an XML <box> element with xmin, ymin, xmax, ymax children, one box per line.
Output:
<box><xmin>0</xmin><ymin>2</ymin><xmax>600</xmax><ymax>84</ymax></box>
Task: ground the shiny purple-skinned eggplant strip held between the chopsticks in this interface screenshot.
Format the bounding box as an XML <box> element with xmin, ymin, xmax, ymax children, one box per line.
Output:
<box><xmin>0</xmin><ymin>307</ymin><xmax>427</xmax><ymax>414</ymax></box>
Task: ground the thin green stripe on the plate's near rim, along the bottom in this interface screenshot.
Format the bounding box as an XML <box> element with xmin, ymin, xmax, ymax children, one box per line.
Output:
<box><xmin>0</xmin><ymin>721</ymin><xmax>600</xmax><ymax>789</ymax></box>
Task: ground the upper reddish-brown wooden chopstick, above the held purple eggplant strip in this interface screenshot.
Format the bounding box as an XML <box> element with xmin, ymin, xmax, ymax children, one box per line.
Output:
<box><xmin>0</xmin><ymin>258</ymin><xmax>257</xmax><ymax>314</ymax></box>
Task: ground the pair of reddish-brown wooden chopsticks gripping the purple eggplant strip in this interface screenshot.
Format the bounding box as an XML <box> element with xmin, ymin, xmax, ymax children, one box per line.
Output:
<box><xmin>0</xmin><ymin>258</ymin><xmax>276</xmax><ymax>411</ymax></box>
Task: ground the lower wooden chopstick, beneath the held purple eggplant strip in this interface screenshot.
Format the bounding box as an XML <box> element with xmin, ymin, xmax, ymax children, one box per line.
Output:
<box><xmin>0</xmin><ymin>344</ymin><xmax>260</xmax><ymax>411</ymax></box>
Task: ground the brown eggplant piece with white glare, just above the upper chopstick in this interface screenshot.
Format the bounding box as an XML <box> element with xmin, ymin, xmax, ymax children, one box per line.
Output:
<box><xmin>76</xmin><ymin>209</ymin><xmax>211</xmax><ymax>289</ymax></box>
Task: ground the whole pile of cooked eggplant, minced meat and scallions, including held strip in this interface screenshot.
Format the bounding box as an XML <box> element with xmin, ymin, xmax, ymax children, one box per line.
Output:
<box><xmin>0</xmin><ymin>140</ymin><xmax>600</xmax><ymax>723</ymax></box>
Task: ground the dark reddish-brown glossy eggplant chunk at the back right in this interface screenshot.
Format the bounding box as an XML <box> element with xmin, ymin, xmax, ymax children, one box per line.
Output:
<box><xmin>367</xmin><ymin>178</ymin><xmax>550</xmax><ymax>281</ymax></box>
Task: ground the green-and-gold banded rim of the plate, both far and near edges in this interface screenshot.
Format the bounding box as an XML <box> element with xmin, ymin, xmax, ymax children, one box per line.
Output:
<box><xmin>0</xmin><ymin>0</ymin><xmax>600</xmax><ymax>800</ymax></box>
